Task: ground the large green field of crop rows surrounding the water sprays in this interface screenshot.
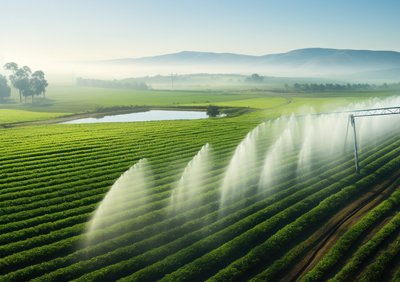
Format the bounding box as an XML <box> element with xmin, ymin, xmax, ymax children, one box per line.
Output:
<box><xmin>0</xmin><ymin>90</ymin><xmax>400</xmax><ymax>281</ymax></box>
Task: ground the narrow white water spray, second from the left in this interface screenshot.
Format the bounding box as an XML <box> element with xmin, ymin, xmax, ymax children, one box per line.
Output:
<box><xmin>170</xmin><ymin>143</ymin><xmax>212</xmax><ymax>214</ymax></box>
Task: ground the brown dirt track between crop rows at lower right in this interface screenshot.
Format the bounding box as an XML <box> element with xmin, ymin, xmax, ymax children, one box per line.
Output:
<box><xmin>281</xmin><ymin>170</ymin><xmax>400</xmax><ymax>282</ymax></box>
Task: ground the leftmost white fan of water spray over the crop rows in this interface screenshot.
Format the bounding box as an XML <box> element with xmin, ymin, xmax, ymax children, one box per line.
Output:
<box><xmin>86</xmin><ymin>159</ymin><xmax>152</xmax><ymax>245</ymax></box>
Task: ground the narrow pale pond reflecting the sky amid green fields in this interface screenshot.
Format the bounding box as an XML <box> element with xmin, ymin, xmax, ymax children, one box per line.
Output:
<box><xmin>62</xmin><ymin>110</ymin><xmax>208</xmax><ymax>124</ymax></box>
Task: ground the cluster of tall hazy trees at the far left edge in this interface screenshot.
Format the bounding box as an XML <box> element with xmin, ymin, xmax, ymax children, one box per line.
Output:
<box><xmin>0</xmin><ymin>62</ymin><xmax>48</xmax><ymax>103</ymax></box>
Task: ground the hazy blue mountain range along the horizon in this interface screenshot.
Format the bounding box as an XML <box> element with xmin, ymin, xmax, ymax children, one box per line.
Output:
<box><xmin>92</xmin><ymin>48</ymin><xmax>400</xmax><ymax>80</ymax></box>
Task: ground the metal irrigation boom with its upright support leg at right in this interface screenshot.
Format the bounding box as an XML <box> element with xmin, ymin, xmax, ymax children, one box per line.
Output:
<box><xmin>349</xmin><ymin>107</ymin><xmax>400</xmax><ymax>174</ymax></box>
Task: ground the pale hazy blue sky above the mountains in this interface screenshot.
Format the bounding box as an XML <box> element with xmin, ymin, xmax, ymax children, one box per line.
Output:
<box><xmin>0</xmin><ymin>0</ymin><xmax>400</xmax><ymax>66</ymax></box>
